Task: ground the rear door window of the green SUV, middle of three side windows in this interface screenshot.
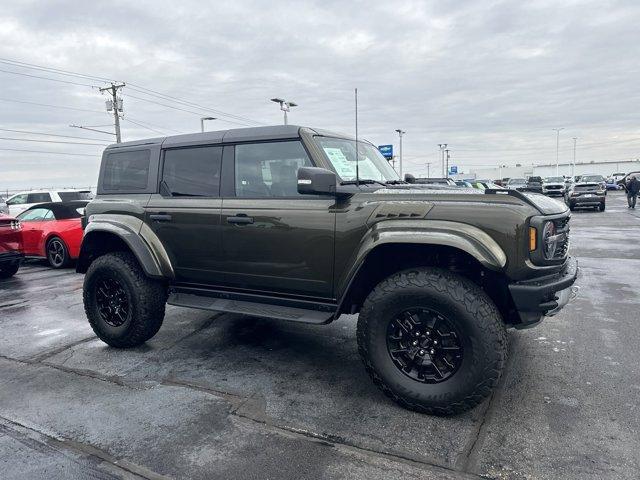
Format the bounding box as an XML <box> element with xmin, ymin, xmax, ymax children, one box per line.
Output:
<box><xmin>160</xmin><ymin>147</ymin><xmax>222</xmax><ymax>197</ymax></box>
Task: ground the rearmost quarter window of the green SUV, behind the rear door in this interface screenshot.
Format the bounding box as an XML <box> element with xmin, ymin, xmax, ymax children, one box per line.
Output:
<box><xmin>102</xmin><ymin>150</ymin><xmax>151</xmax><ymax>192</ymax></box>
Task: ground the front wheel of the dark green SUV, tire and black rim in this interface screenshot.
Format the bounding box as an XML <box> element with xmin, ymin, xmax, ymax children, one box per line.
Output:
<box><xmin>357</xmin><ymin>268</ymin><xmax>507</xmax><ymax>415</ymax></box>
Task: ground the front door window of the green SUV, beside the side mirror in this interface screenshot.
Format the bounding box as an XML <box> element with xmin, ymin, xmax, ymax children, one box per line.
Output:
<box><xmin>235</xmin><ymin>141</ymin><xmax>311</xmax><ymax>198</ymax></box>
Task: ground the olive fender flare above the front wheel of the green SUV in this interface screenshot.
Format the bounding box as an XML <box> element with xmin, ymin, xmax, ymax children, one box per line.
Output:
<box><xmin>339</xmin><ymin>220</ymin><xmax>507</xmax><ymax>295</ymax></box>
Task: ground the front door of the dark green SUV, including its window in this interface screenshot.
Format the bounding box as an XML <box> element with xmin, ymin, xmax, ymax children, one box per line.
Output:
<box><xmin>221</xmin><ymin>140</ymin><xmax>335</xmax><ymax>299</ymax></box>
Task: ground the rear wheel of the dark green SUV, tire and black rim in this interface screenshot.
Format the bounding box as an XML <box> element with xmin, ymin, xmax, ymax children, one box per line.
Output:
<box><xmin>83</xmin><ymin>252</ymin><xmax>167</xmax><ymax>348</ymax></box>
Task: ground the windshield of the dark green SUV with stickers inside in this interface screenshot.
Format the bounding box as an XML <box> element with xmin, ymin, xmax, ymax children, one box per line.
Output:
<box><xmin>315</xmin><ymin>137</ymin><xmax>400</xmax><ymax>182</ymax></box>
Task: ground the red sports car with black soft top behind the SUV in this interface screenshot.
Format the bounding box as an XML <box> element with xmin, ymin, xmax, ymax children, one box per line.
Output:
<box><xmin>18</xmin><ymin>201</ymin><xmax>88</xmax><ymax>268</ymax></box>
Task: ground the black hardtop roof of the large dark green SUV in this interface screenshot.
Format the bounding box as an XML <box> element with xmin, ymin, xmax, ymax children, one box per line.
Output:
<box><xmin>107</xmin><ymin>125</ymin><xmax>364</xmax><ymax>149</ymax></box>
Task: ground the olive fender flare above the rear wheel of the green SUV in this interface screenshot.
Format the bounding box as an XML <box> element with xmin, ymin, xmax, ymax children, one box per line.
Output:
<box><xmin>76</xmin><ymin>215</ymin><xmax>174</xmax><ymax>279</ymax></box>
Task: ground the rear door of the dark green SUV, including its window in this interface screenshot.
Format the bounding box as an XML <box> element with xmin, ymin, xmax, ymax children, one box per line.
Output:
<box><xmin>145</xmin><ymin>145</ymin><xmax>223</xmax><ymax>285</ymax></box>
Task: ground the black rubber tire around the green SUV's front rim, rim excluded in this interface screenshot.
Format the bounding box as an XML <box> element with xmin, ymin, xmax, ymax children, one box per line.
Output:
<box><xmin>357</xmin><ymin>268</ymin><xmax>508</xmax><ymax>415</ymax></box>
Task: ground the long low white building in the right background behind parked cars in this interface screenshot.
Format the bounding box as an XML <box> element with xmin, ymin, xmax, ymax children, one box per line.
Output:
<box><xmin>458</xmin><ymin>160</ymin><xmax>640</xmax><ymax>180</ymax></box>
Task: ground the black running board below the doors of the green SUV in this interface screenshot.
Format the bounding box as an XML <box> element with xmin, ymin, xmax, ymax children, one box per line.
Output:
<box><xmin>167</xmin><ymin>292</ymin><xmax>334</xmax><ymax>325</ymax></box>
